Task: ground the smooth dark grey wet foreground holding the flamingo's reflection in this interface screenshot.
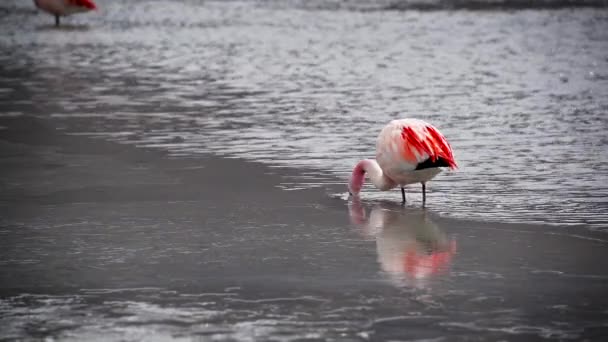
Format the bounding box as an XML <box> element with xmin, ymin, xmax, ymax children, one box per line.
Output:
<box><xmin>0</xmin><ymin>116</ymin><xmax>608</xmax><ymax>341</ymax></box>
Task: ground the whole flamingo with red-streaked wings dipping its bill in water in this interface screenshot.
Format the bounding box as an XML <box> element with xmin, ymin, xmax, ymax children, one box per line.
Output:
<box><xmin>348</xmin><ymin>119</ymin><xmax>457</xmax><ymax>206</ymax></box>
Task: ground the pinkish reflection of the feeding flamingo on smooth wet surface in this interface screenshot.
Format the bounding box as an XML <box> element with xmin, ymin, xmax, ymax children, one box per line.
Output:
<box><xmin>348</xmin><ymin>197</ymin><xmax>456</xmax><ymax>287</ymax></box>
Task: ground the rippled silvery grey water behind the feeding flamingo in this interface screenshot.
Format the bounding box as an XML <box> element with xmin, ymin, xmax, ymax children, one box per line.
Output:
<box><xmin>0</xmin><ymin>0</ymin><xmax>608</xmax><ymax>230</ymax></box>
